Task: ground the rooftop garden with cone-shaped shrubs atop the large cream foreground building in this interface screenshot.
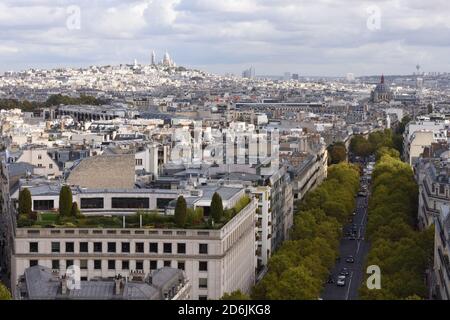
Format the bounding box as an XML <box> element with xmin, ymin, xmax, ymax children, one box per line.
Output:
<box><xmin>17</xmin><ymin>187</ymin><xmax>251</xmax><ymax>230</ymax></box>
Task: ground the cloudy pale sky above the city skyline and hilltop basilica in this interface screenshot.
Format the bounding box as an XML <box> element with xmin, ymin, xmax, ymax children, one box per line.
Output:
<box><xmin>0</xmin><ymin>0</ymin><xmax>450</xmax><ymax>75</ymax></box>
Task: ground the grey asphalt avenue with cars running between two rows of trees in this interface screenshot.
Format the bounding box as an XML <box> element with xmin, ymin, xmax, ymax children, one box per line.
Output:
<box><xmin>322</xmin><ymin>172</ymin><xmax>369</xmax><ymax>300</ymax></box>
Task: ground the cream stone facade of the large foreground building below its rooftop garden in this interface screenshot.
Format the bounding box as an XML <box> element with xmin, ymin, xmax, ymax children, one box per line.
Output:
<box><xmin>11</xmin><ymin>200</ymin><xmax>257</xmax><ymax>299</ymax></box>
